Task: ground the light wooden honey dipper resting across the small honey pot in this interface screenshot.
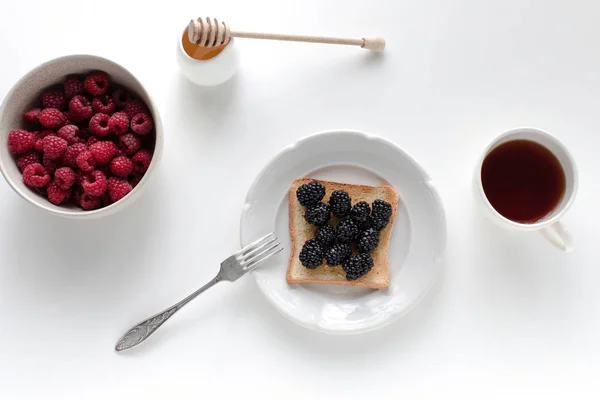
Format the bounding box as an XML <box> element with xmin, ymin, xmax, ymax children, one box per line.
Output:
<box><xmin>188</xmin><ymin>17</ymin><xmax>385</xmax><ymax>52</ymax></box>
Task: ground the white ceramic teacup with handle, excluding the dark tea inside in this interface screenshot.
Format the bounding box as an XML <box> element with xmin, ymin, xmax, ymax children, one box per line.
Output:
<box><xmin>475</xmin><ymin>128</ymin><xmax>578</xmax><ymax>252</ymax></box>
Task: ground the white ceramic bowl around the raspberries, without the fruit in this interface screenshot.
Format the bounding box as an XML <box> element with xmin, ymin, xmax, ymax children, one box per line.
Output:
<box><xmin>0</xmin><ymin>54</ymin><xmax>164</xmax><ymax>219</ymax></box>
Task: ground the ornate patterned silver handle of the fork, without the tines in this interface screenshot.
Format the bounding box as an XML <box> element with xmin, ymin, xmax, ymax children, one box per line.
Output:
<box><xmin>115</xmin><ymin>276</ymin><xmax>221</xmax><ymax>351</ymax></box>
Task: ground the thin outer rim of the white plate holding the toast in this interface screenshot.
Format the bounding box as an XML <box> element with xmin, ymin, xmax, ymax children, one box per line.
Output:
<box><xmin>239</xmin><ymin>128</ymin><xmax>448</xmax><ymax>335</ymax></box>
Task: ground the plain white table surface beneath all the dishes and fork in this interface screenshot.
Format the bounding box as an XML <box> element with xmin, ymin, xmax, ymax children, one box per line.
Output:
<box><xmin>0</xmin><ymin>0</ymin><xmax>600</xmax><ymax>399</ymax></box>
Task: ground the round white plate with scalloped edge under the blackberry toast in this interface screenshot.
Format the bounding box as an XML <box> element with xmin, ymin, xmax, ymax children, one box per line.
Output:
<box><xmin>240</xmin><ymin>131</ymin><xmax>446</xmax><ymax>333</ymax></box>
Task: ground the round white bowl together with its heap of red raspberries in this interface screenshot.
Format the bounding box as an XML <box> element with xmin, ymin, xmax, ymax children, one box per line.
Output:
<box><xmin>0</xmin><ymin>55</ymin><xmax>163</xmax><ymax>218</ymax></box>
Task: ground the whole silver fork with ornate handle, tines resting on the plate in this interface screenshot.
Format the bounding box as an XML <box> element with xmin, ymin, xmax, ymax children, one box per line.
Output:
<box><xmin>115</xmin><ymin>232</ymin><xmax>283</xmax><ymax>351</ymax></box>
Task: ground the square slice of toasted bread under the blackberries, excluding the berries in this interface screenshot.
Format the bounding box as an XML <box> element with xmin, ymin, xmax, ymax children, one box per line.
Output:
<box><xmin>287</xmin><ymin>178</ymin><xmax>398</xmax><ymax>289</ymax></box>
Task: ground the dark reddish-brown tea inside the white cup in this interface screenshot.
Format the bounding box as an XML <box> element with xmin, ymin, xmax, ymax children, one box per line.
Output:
<box><xmin>481</xmin><ymin>140</ymin><xmax>566</xmax><ymax>223</ymax></box>
